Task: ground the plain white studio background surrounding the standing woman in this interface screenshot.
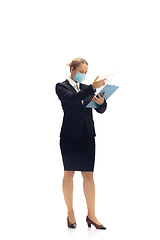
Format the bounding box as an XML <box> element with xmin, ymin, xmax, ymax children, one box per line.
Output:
<box><xmin>0</xmin><ymin>0</ymin><xmax>160</xmax><ymax>240</ymax></box>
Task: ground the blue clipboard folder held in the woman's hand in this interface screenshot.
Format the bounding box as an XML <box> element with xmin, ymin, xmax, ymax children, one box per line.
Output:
<box><xmin>86</xmin><ymin>84</ymin><xmax>119</xmax><ymax>108</ymax></box>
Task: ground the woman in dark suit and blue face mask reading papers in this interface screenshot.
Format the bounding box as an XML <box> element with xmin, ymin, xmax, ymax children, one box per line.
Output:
<box><xmin>56</xmin><ymin>58</ymin><xmax>107</xmax><ymax>229</ymax></box>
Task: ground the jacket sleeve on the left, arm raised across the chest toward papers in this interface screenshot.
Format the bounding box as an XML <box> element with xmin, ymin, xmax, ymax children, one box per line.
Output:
<box><xmin>56</xmin><ymin>83</ymin><xmax>95</xmax><ymax>103</ymax></box>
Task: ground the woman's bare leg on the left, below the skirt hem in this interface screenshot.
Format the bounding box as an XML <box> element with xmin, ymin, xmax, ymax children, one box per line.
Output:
<box><xmin>62</xmin><ymin>171</ymin><xmax>75</xmax><ymax>224</ymax></box>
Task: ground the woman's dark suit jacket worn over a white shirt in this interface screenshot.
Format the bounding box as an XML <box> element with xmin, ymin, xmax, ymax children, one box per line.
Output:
<box><xmin>56</xmin><ymin>80</ymin><xmax>107</xmax><ymax>138</ymax></box>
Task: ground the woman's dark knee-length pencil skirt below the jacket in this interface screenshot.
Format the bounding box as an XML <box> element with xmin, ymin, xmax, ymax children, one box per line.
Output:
<box><xmin>60</xmin><ymin>122</ymin><xmax>95</xmax><ymax>172</ymax></box>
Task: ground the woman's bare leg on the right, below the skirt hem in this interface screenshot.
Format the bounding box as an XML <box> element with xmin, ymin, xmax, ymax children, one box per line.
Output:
<box><xmin>82</xmin><ymin>172</ymin><xmax>100</xmax><ymax>225</ymax></box>
